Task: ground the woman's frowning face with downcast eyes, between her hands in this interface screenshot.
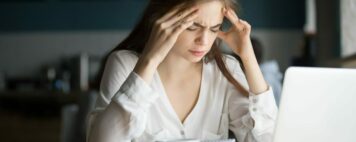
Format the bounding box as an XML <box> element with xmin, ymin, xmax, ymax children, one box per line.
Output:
<box><xmin>171</xmin><ymin>1</ymin><xmax>224</xmax><ymax>62</ymax></box>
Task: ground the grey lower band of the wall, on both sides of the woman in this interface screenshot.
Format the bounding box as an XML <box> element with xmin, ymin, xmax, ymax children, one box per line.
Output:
<box><xmin>0</xmin><ymin>29</ymin><xmax>303</xmax><ymax>76</ymax></box>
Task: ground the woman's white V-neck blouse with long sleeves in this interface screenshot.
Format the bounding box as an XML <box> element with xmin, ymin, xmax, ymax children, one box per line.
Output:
<box><xmin>88</xmin><ymin>50</ymin><xmax>277</xmax><ymax>142</ymax></box>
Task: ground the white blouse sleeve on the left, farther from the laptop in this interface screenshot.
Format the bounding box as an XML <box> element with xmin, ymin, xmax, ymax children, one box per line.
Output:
<box><xmin>87</xmin><ymin>51</ymin><xmax>158</xmax><ymax>142</ymax></box>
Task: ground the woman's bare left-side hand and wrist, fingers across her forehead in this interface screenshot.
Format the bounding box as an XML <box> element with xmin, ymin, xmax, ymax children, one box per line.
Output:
<box><xmin>134</xmin><ymin>6</ymin><xmax>198</xmax><ymax>83</ymax></box>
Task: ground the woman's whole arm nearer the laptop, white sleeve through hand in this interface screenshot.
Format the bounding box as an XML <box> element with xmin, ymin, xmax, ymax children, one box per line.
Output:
<box><xmin>219</xmin><ymin>9</ymin><xmax>277</xmax><ymax>142</ymax></box>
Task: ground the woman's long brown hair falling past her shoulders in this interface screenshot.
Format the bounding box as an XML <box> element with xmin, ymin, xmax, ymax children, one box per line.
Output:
<box><xmin>97</xmin><ymin>0</ymin><xmax>248</xmax><ymax>96</ymax></box>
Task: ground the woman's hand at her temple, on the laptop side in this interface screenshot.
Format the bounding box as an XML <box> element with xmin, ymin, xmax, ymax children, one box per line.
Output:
<box><xmin>218</xmin><ymin>8</ymin><xmax>254</xmax><ymax>58</ymax></box>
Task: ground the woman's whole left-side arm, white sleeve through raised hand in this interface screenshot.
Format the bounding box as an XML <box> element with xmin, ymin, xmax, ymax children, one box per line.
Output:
<box><xmin>88</xmin><ymin>5</ymin><xmax>197</xmax><ymax>142</ymax></box>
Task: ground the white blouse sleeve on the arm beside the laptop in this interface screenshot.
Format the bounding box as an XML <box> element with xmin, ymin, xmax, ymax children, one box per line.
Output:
<box><xmin>227</xmin><ymin>57</ymin><xmax>278</xmax><ymax>142</ymax></box>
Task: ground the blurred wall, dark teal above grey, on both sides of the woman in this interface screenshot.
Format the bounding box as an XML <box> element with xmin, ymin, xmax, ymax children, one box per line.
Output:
<box><xmin>0</xmin><ymin>0</ymin><xmax>305</xmax><ymax>76</ymax></box>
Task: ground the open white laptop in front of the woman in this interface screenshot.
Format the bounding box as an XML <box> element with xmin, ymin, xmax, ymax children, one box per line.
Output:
<box><xmin>273</xmin><ymin>67</ymin><xmax>356</xmax><ymax>142</ymax></box>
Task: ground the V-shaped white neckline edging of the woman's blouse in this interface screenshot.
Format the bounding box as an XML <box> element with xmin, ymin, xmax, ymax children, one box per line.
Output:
<box><xmin>155</xmin><ymin>62</ymin><xmax>205</xmax><ymax>127</ymax></box>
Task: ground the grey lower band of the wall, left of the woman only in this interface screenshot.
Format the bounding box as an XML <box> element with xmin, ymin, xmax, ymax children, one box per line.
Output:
<box><xmin>0</xmin><ymin>31</ymin><xmax>127</xmax><ymax>77</ymax></box>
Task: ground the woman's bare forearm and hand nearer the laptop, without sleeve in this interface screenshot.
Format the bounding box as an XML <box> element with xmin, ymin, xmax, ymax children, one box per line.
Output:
<box><xmin>218</xmin><ymin>9</ymin><xmax>268</xmax><ymax>94</ymax></box>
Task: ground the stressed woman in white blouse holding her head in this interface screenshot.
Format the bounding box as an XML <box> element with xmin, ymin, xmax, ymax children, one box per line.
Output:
<box><xmin>88</xmin><ymin>0</ymin><xmax>277</xmax><ymax>142</ymax></box>
